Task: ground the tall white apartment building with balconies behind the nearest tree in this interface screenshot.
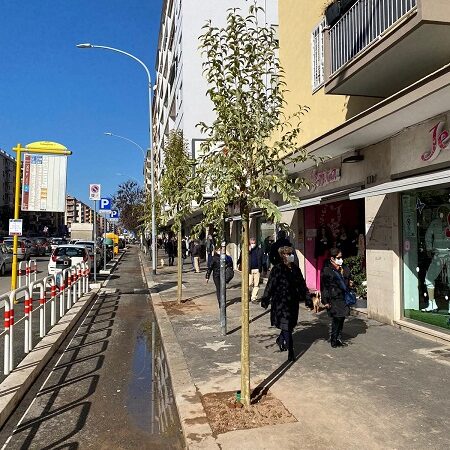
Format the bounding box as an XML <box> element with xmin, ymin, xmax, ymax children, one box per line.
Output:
<box><xmin>151</xmin><ymin>0</ymin><xmax>278</xmax><ymax>182</ymax></box>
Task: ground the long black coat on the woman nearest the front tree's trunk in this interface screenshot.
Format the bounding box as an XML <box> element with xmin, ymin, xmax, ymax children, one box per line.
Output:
<box><xmin>263</xmin><ymin>263</ymin><xmax>306</xmax><ymax>331</ymax></box>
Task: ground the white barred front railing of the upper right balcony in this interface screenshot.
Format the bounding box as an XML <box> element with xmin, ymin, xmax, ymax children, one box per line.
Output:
<box><xmin>330</xmin><ymin>0</ymin><xmax>417</xmax><ymax>74</ymax></box>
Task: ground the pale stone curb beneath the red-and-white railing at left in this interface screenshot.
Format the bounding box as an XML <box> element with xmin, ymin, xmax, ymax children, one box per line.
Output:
<box><xmin>0</xmin><ymin>251</ymin><xmax>126</xmax><ymax>428</ymax></box>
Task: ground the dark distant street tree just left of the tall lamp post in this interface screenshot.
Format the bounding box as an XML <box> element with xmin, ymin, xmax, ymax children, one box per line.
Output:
<box><xmin>112</xmin><ymin>180</ymin><xmax>144</xmax><ymax>233</ymax></box>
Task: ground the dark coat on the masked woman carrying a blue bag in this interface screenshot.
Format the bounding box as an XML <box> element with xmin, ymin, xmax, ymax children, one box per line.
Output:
<box><xmin>320</xmin><ymin>260</ymin><xmax>350</xmax><ymax>317</ymax></box>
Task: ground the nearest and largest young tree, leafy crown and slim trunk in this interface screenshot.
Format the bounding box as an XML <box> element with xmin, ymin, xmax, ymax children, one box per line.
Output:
<box><xmin>191</xmin><ymin>4</ymin><xmax>308</xmax><ymax>405</ymax></box>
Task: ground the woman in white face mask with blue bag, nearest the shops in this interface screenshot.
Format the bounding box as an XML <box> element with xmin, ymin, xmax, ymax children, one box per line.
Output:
<box><xmin>320</xmin><ymin>248</ymin><xmax>352</xmax><ymax>348</ymax></box>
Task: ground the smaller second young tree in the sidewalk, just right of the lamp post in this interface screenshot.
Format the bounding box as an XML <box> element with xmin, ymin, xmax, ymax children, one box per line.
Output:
<box><xmin>161</xmin><ymin>130</ymin><xmax>193</xmax><ymax>303</ymax></box>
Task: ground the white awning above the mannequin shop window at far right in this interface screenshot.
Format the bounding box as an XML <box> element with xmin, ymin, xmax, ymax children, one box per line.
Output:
<box><xmin>350</xmin><ymin>170</ymin><xmax>450</xmax><ymax>200</ymax></box>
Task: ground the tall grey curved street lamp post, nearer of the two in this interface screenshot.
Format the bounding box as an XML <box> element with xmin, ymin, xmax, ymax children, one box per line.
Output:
<box><xmin>77</xmin><ymin>44</ymin><xmax>156</xmax><ymax>275</ymax></box>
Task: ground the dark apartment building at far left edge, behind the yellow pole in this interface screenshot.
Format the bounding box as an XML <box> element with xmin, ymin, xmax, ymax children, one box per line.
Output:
<box><xmin>0</xmin><ymin>149</ymin><xmax>16</xmax><ymax>231</ymax></box>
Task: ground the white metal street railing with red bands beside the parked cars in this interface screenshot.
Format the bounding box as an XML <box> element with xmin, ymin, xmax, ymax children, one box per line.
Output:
<box><xmin>0</xmin><ymin>262</ymin><xmax>90</xmax><ymax>375</ymax></box>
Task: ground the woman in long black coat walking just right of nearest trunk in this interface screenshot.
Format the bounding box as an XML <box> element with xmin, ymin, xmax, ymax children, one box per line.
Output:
<box><xmin>261</xmin><ymin>246</ymin><xmax>306</xmax><ymax>361</ymax></box>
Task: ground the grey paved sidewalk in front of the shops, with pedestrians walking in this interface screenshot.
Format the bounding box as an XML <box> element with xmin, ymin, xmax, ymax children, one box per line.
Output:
<box><xmin>145</xmin><ymin>255</ymin><xmax>450</xmax><ymax>449</ymax></box>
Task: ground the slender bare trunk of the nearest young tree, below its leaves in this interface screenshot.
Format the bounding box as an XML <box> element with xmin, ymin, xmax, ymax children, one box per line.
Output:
<box><xmin>241</xmin><ymin>206</ymin><xmax>250</xmax><ymax>406</ymax></box>
